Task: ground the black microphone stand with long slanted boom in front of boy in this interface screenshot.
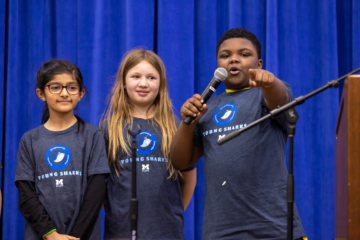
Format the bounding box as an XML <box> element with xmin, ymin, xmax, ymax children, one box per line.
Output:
<box><xmin>216</xmin><ymin>68</ymin><xmax>360</xmax><ymax>240</ymax></box>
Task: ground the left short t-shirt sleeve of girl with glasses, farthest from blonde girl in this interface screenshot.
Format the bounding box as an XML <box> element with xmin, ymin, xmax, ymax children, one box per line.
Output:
<box><xmin>15</xmin><ymin>135</ymin><xmax>35</xmax><ymax>182</ymax></box>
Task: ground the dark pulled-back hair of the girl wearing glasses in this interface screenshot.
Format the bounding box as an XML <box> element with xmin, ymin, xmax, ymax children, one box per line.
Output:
<box><xmin>36</xmin><ymin>59</ymin><xmax>89</xmax><ymax>131</ymax></box>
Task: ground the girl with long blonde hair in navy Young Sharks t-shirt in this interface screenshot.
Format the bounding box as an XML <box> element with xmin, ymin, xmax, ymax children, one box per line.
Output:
<box><xmin>101</xmin><ymin>49</ymin><xmax>196</xmax><ymax>240</ymax></box>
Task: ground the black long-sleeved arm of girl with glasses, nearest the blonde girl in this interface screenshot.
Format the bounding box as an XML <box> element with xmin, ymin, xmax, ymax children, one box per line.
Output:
<box><xmin>70</xmin><ymin>174</ymin><xmax>107</xmax><ymax>240</ymax></box>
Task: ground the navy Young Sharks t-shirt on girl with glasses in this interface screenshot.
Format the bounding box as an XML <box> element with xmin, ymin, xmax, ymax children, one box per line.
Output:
<box><xmin>15</xmin><ymin>123</ymin><xmax>109</xmax><ymax>240</ymax></box>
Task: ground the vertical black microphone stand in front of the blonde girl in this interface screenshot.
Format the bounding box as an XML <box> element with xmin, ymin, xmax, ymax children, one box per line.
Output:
<box><xmin>128</xmin><ymin>124</ymin><xmax>141</xmax><ymax>240</ymax></box>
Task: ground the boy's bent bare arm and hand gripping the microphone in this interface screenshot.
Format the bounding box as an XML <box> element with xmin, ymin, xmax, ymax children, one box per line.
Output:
<box><xmin>170</xmin><ymin>94</ymin><xmax>208</xmax><ymax>170</ymax></box>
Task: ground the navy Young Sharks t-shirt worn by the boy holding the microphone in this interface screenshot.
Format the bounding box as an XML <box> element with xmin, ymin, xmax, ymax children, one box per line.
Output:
<box><xmin>194</xmin><ymin>83</ymin><xmax>305</xmax><ymax>240</ymax></box>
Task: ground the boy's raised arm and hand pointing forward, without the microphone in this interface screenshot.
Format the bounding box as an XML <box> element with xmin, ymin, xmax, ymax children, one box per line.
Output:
<box><xmin>249</xmin><ymin>69</ymin><xmax>289</xmax><ymax>110</ymax></box>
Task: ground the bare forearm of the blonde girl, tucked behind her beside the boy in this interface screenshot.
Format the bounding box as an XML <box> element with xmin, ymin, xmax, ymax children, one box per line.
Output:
<box><xmin>180</xmin><ymin>168</ymin><xmax>196</xmax><ymax>210</ymax></box>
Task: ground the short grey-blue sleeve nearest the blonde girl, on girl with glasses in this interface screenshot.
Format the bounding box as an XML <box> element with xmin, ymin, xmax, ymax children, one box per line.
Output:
<box><xmin>88</xmin><ymin>130</ymin><xmax>110</xmax><ymax>176</ymax></box>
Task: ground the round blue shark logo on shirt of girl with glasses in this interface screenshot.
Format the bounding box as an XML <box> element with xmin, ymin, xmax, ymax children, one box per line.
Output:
<box><xmin>45</xmin><ymin>145</ymin><xmax>71</xmax><ymax>170</ymax></box>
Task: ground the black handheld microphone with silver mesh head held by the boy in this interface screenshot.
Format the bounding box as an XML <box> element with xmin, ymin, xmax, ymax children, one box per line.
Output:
<box><xmin>184</xmin><ymin>68</ymin><xmax>227</xmax><ymax>125</ymax></box>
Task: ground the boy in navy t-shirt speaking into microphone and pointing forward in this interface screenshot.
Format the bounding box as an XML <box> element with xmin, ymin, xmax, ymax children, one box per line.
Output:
<box><xmin>171</xmin><ymin>28</ymin><xmax>305</xmax><ymax>239</ymax></box>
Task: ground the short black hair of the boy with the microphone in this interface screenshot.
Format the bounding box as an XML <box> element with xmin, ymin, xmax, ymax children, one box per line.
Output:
<box><xmin>216</xmin><ymin>28</ymin><xmax>261</xmax><ymax>59</ymax></box>
